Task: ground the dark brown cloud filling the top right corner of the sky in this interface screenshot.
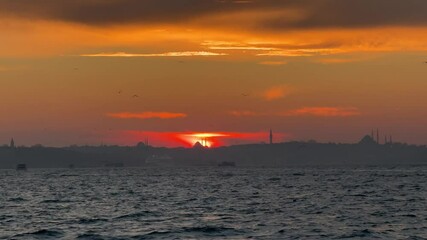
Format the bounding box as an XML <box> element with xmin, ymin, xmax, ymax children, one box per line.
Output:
<box><xmin>263</xmin><ymin>0</ymin><xmax>427</xmax><ymax>29</ymax></box>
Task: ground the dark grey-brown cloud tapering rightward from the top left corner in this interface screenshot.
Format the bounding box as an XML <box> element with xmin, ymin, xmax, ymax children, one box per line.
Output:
<box><xmin>0</xmin><ymin>0</ymin><xmax>251</xmax><ymax>25</ymax></box>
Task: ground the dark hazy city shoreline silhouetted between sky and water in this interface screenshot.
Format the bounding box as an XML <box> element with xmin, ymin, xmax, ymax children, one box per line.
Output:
<box><xmin>0</xmin><ymin>135</ymin><xmax>427</xmax><ymax>168</ymax></box>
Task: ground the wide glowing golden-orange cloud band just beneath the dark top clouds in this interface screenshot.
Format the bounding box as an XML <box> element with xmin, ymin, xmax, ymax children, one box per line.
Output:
<box><xmin>0</xmin><ymin>16</ymin><xmax>427</xmax><ymax>58</ymax></box>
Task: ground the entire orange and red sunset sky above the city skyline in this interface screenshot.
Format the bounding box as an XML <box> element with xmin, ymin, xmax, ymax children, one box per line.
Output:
<box><xmin>0</xmin><ymin>0</ymin><xmax>427</xmax><ymax>146</ymax></box>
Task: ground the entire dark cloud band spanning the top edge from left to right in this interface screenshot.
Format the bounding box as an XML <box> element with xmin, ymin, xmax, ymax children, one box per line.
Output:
<box><xmin>0</xmin><ymin>0</ymin><xmax>427</xmax><ymax>30</ymax></box>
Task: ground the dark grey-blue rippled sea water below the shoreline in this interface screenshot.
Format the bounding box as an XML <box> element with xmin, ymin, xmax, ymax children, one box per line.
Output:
<box><xmin>0</xmin><ymin>167</ymin><xmax>427</xmax><ymax>239</ymax></box>
